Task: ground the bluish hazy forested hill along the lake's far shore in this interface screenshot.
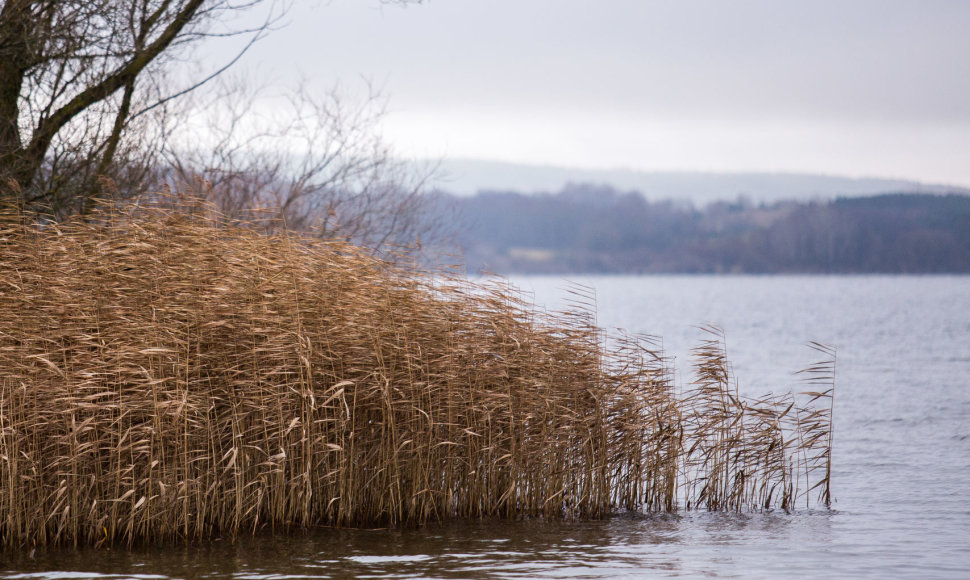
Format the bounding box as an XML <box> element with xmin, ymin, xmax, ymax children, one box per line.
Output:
<box><xmin>454</xmin><ymin>186</ymin><xmax>970</xmax><ymax>273</ymax></box>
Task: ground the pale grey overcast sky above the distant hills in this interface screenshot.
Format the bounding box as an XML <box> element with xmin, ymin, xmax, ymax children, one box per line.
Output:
<box><xmin>200</xmin><ymin>0</ymin><xmax>970</xmax><ymax>186</ymax></box>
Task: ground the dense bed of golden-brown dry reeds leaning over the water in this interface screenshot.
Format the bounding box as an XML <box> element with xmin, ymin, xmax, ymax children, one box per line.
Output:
<box><xmin>0</xmin><ymin>202</ymin><xmax>835</xmax><ymax>549</ymax></box>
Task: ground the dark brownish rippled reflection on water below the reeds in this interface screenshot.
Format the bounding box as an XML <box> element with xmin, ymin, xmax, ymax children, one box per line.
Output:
<box><xmin>3</xmin><ymin>512</ymin><xmax>833</xmax><ymax>578</ymax></box>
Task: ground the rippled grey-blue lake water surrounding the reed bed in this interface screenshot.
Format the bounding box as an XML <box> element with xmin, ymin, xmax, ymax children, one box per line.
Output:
<box><xmin>0</xmin><ymin>276</ymin><xmax>970</xmax><ymax>578</ymax></box>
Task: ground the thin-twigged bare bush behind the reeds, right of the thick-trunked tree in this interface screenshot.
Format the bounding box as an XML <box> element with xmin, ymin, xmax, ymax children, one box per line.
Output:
<box><xmin>162</xmin><ymin>76</ymin><xmax>450</xmax><ymax>254</ymax></box>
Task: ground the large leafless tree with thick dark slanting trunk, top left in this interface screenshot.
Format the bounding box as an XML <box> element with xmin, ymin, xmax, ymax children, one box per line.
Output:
<box><xmin>0</xmin><ymin>0</ymin><xmax>294</xmax><ymax>215</ymax></box>
